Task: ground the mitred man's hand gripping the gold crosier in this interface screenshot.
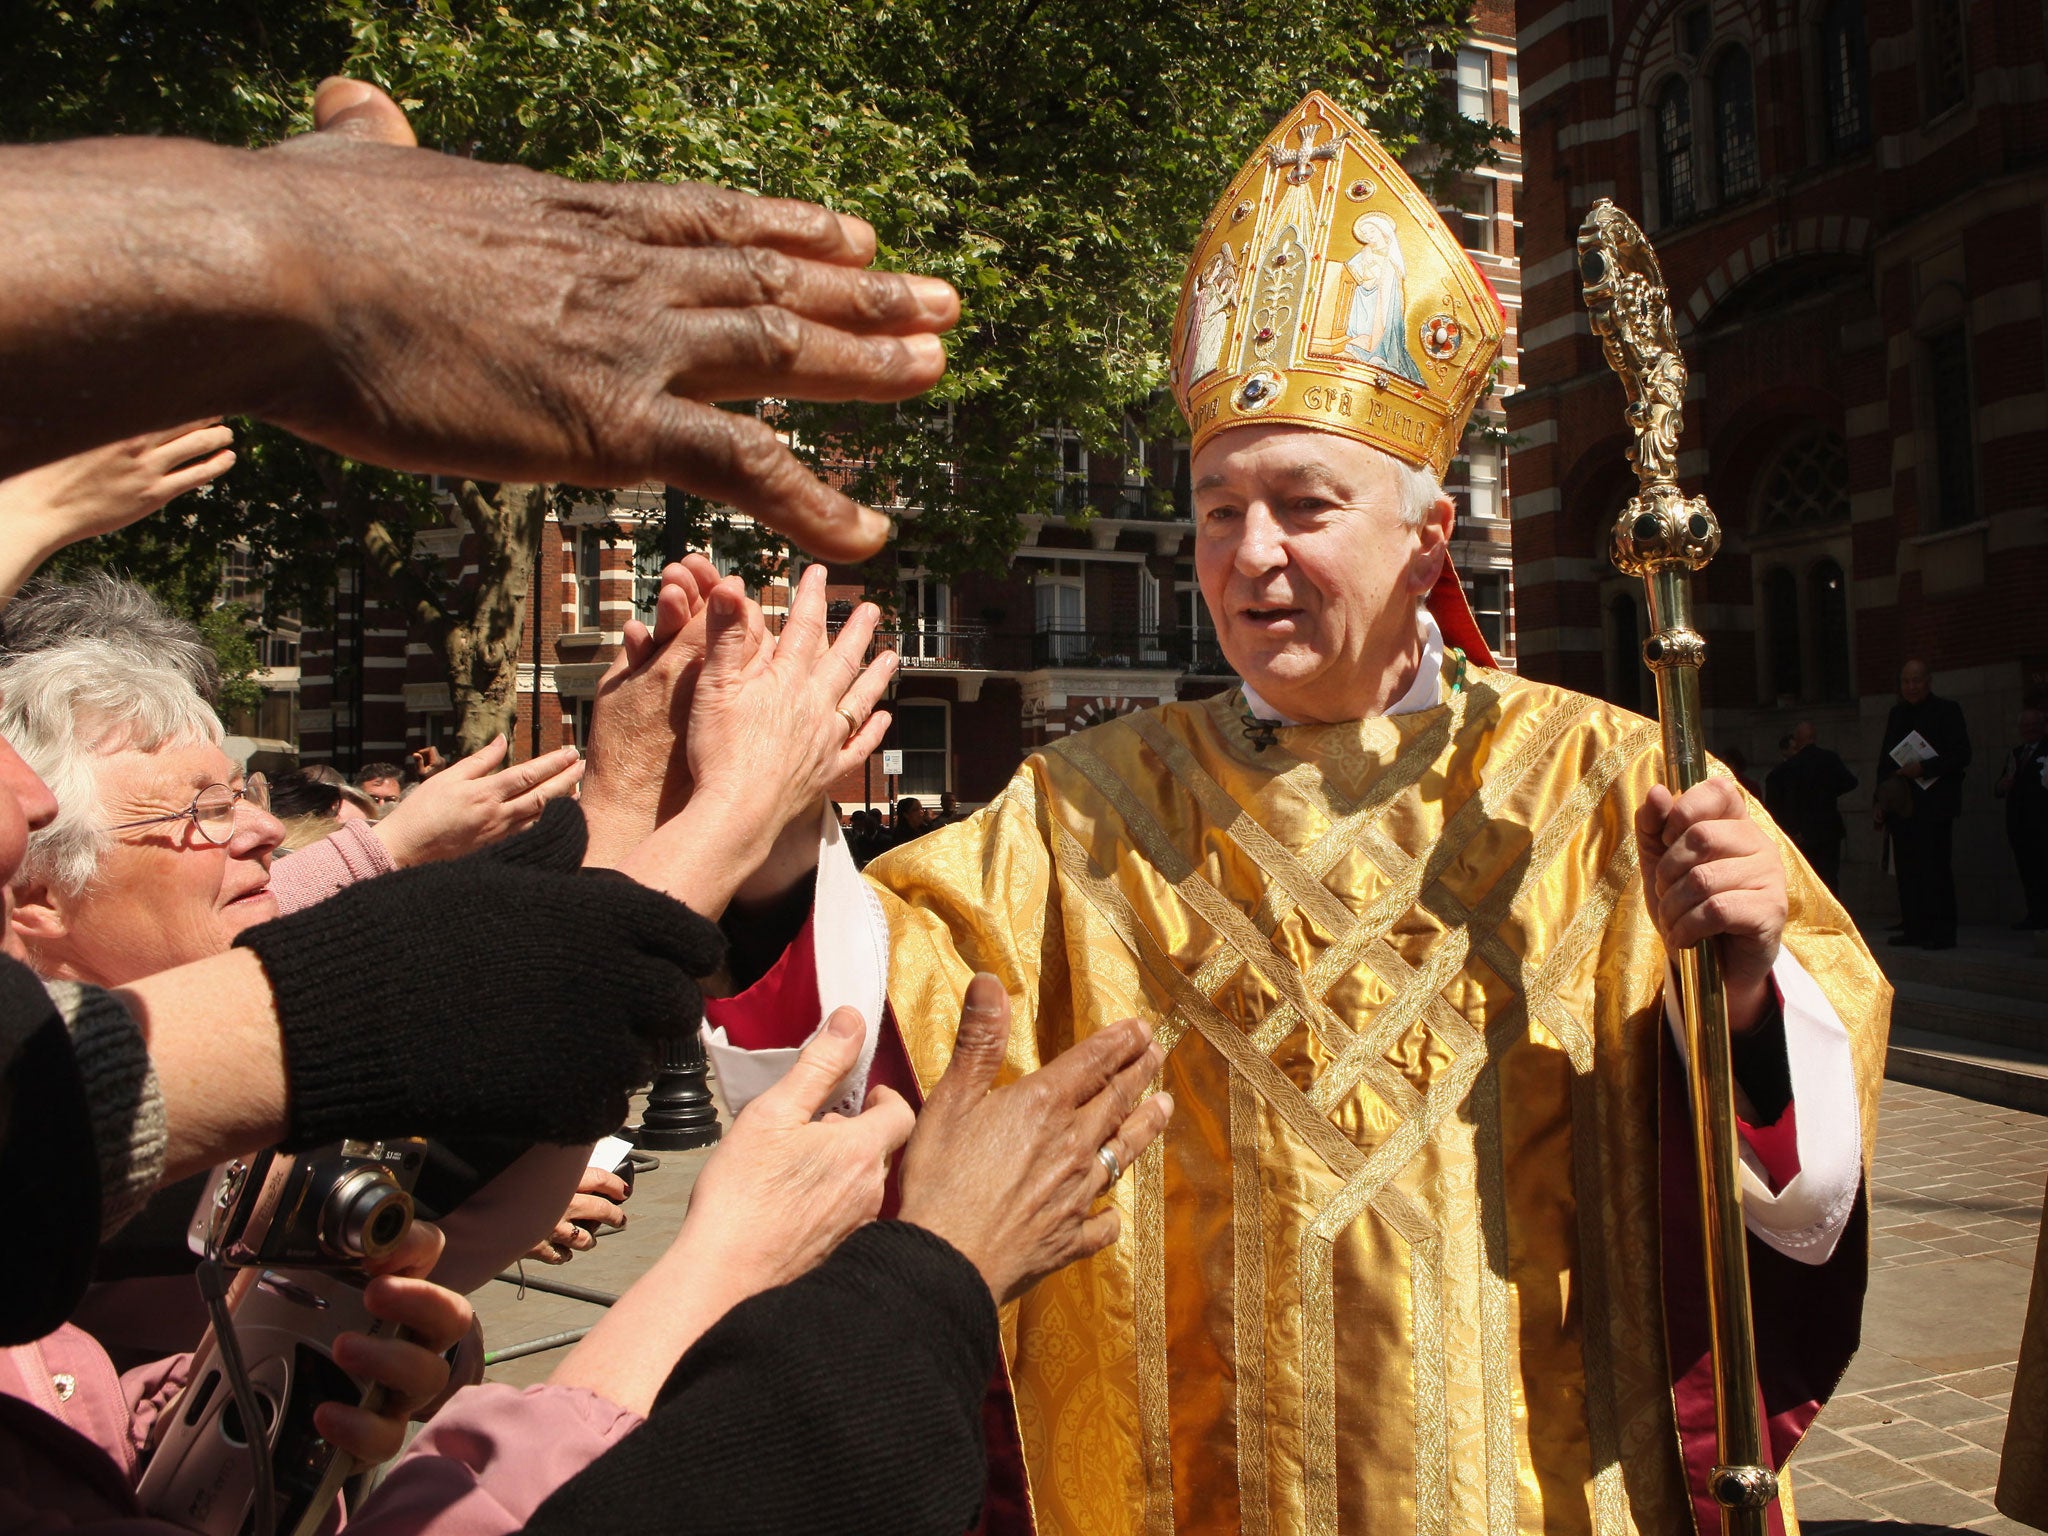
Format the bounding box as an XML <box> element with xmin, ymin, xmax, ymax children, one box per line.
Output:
<box><xmin>1636</xmin><ymin>778</ymin><xmax>1788</xmax><ymax>1034</ymax></box>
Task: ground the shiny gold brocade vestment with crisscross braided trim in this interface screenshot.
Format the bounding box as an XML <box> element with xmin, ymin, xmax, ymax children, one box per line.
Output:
<box><xmin>868</xmin><ymin>657</ymin><xmax>1886</xmax><ymax>1536</ymax></box>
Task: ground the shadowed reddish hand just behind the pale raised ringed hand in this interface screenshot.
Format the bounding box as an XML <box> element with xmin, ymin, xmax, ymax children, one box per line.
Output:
<box><xmin>582</xmin><ymin>555</ymin><xmax>724</xmax><ymax>866</ymax></box>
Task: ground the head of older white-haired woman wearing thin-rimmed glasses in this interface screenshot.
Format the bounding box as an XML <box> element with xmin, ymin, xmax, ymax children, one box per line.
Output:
<box><xmin>0</xmin><ymin>639</ymin><xmax>285</xmax><ymax>987</ymax></box>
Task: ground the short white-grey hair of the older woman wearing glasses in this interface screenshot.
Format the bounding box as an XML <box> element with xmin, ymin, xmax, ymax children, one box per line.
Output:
<box><xmin>0</xmin><ymin>594</ymin><xmax>221</xmax><ymax>895</ymax></box>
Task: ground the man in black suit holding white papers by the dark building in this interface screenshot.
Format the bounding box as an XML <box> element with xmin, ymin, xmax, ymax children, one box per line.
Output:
<box><xmin>1876</xmin><ymin>659</ymin><xmax>1970</xmax><ymax>950</ymax></box>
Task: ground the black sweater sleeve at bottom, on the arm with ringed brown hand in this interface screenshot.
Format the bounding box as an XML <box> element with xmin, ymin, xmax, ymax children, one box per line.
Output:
<box><xmin>526</xmin><ymin>1221</ymin><xmax>997</xmax><ymax>1536</ymax></box>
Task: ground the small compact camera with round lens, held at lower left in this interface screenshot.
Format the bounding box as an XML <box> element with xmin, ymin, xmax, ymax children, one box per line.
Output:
<box><xmin>186</xmin><ymin>1137</ymin><xmax>426</xmax><ymax>1270</ymax></box>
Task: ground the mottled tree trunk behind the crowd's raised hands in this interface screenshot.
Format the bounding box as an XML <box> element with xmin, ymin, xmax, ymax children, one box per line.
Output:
<box><xmin>440</xmin><ymin>479</ymin><xmax>553</xmax><ymax>756</ymax></box>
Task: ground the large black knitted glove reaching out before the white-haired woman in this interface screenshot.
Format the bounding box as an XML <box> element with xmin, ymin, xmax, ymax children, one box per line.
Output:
<box><xmin>236</xmin><ymin>801</ymin><xmax>723</xmax><ymax>1147</ymax></box>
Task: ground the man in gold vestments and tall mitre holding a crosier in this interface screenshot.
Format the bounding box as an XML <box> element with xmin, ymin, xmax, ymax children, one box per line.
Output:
<box><xmin>700</xmin><ymin>96</ymin><xmax>1888</xmax><ymax>1536</ymax></box>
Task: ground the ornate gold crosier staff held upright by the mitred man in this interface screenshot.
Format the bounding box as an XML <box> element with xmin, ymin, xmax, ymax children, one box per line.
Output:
<box><xmin>1579</xmin><ymin>199</ymin><xmax>1778</xmax><ymax>1536</ymax></box>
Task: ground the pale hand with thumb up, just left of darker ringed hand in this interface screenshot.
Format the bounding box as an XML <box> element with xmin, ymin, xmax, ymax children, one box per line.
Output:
<box><xmin>676</xmin><ymin>1008</ymin><xmax>915</xmax><ymax>1298</ymax></box>
